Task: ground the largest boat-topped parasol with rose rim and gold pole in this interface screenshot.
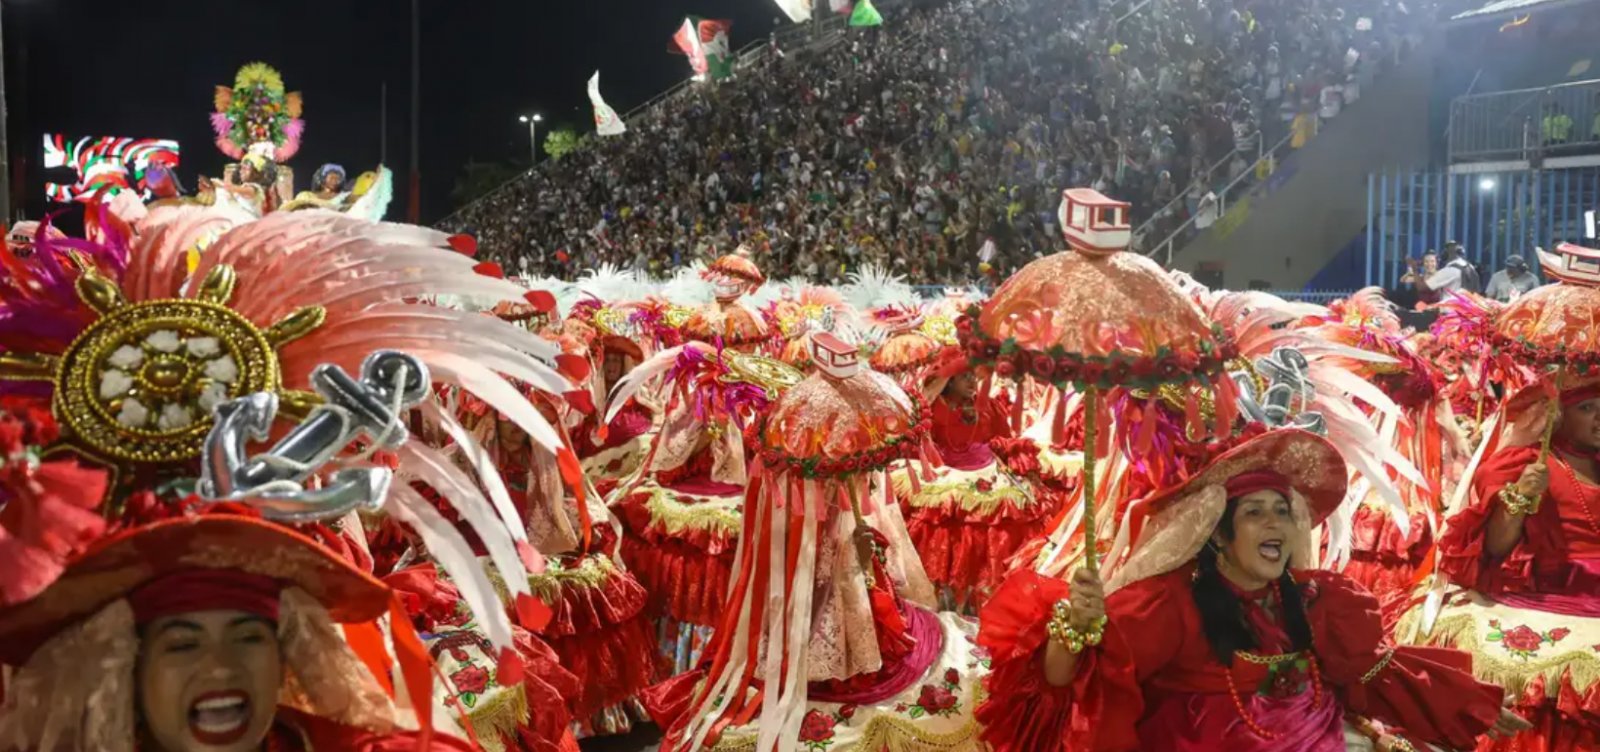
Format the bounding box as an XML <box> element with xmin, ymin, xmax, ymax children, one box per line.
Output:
<box><xmin>957</xmin><ymin>189</ymin><xmax>1237</xmax><ymax>579</ymax></box>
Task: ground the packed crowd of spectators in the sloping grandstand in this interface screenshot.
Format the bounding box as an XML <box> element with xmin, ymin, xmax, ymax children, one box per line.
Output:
<box><xmin>445</xmin><ymin>0</ymin><xmax>1430</xmax><ymax>283</ymax></box>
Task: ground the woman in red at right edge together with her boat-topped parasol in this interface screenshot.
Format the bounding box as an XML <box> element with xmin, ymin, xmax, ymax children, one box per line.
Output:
<box><xmin>1395</xmin><ymin>243</ymin><xmax>1600</xmax><ymax>752</ymax></box>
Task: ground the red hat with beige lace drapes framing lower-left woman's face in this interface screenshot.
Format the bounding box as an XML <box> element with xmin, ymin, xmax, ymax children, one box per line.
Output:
<box><xmin>0</xmin><ymin>514</ymin><xmax>444</xmax><ymax>752</ymax></box>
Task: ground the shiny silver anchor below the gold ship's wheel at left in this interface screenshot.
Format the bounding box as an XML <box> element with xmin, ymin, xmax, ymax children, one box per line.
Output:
<box><xmin>197</xmin><ymin>350</ymin><xmax>430</xmax><ymax>523</ymax></box>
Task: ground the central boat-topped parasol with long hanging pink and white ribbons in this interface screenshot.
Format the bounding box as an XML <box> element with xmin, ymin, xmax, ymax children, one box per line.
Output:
<box><xmin>658</xmin><ymin>334</ymin><xmax>938</xmax><ymax>750</ymax></box>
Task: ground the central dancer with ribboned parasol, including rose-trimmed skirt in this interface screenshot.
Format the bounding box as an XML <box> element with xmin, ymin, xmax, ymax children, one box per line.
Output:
<box><xmin>646</xmin><ymin>334</ymin><xmax>982</xmax><ymax>752</ymax></box>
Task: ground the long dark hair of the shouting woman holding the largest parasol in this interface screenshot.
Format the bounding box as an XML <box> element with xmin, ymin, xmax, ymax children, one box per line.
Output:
<box><xmin>1194</xmin><ymin>499</ymin><xmax>1310</xmax><ymax>666</ymax></box>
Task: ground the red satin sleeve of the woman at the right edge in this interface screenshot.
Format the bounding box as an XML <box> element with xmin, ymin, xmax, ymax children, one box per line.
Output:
<box><xmin>1438</xmin><ymin>446</ymin><xmax>1554</xmax><ymax>592</ymax></box>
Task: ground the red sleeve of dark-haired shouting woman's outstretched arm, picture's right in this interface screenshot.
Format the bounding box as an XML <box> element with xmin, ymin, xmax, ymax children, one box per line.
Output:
<box><xmin>1307</xmin><ymin>571</ymin><xmax>1502</xmax><ymax>749</ymax></box>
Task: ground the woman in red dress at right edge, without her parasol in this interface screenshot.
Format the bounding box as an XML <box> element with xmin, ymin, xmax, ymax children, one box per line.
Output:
<box><xmin>1427</xmin><ymin>376</ymin><xmax>1600</xmax><ymax>752</ymax></box>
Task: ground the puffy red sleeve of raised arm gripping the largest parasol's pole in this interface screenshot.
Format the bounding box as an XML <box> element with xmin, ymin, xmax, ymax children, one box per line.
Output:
<box><xmin>976</xmin><ymin>571</ymin><xmax>1182</xmax><ymax>752</ymax></box>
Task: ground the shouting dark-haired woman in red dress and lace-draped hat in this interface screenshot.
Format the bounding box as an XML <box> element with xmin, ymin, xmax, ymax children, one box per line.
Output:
<box><xmin>978</xmin><ymin>429</ymin><xmax>1520</xmax><ymax>752</ymax></box>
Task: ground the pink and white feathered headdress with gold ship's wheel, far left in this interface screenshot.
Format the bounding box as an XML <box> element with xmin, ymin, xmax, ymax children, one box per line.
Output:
<box><xmin>0</xmin><ymin>206</ymin><xmax>571</xmax><ymax>681</ymax></box>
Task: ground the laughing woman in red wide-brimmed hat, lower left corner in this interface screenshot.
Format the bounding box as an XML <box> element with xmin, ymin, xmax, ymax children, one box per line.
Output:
<box><xmin>0</xmin><ymin>514</ymin><xmax>475</xmax><ymax>752</ymax></box>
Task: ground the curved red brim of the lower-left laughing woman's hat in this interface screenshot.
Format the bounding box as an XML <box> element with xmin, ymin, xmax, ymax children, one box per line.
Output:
<box><xmin>0</xmin><ymin>514</ymin><xmax>390</xmax><ymax>666</ymax></box>
